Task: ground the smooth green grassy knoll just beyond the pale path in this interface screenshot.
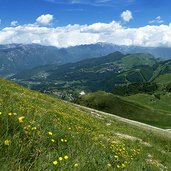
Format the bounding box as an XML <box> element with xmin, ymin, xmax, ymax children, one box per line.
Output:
<box><xmin>77</xmin><ymin>92</ymin><xmax>171</xmax><ymax>128</ymax></box>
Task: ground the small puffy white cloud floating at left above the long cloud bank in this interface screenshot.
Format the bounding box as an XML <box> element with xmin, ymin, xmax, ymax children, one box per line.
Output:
<box><xmin>36</xmin><ymin>14</ymin><xmax>53</xmax><ymax>26</ymax></box>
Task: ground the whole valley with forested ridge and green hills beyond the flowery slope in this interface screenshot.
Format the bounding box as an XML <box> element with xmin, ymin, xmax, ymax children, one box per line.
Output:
<box><xmin>5</xmin><ymin>49</ymin><xmax>171</xmax><ymax>129</ymax></box>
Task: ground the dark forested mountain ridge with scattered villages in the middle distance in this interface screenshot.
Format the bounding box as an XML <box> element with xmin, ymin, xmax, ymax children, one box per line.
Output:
<box><xmin>12</xmin><ymin>52</ymin><xmax>157</xmax><ymax>95</ymax></box>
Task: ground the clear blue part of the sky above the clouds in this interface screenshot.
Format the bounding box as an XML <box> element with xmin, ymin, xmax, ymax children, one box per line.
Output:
<box><xmin>0</xmin><ymin>0</ymin><xmax>171</xmax><ymax>28</ymax></box>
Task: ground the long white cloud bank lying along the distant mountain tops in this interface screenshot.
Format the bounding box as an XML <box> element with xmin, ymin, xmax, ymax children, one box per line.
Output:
<box><xmin>0</xmin><ymin>17</ymin><xmax>171</xmax><ymax>47</ymax></box>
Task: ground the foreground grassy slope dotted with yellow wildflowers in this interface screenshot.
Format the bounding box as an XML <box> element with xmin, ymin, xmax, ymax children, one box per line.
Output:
<box><xmin>0</xmin><ymin>79</ymin><xmax>171</xmax><ymax>171</ymax></box>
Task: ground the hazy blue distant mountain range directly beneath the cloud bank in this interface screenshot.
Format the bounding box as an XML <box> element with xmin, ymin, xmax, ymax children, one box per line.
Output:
<box><xmin>0</xmin><ymin>43</ymin><xmax>171</xmax><ymax>76</ymax></box>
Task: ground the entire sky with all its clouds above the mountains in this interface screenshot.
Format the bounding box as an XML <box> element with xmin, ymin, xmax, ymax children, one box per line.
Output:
<box><xmin>0</xmin><ymin>0</ymin><xmax>171</xmax><ymax>47</ymax></box>
